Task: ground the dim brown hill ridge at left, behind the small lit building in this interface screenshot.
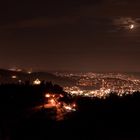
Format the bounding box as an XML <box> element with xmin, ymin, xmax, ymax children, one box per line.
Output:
<box><xmin>0</xmin><ymin>69</ymin><xmax>75</xmax><ymax>86</ymax></box>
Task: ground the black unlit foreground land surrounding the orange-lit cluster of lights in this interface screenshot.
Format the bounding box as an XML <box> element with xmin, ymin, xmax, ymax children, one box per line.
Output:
<box><xmin>0</xmin><ymin>85</ymin><xmax>140</xmax><ymax>140</ymax></box>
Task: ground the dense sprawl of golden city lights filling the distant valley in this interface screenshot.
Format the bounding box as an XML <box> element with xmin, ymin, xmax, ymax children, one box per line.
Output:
<box><xmin>61</xmin><ymin>72</ymin><xmax>140</xmax><ymax>99</ymax></box>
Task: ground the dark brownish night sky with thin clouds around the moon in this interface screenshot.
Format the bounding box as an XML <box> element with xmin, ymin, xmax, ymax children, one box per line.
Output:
<box><xmin>0</xmin><ymin>0</ymin><xmax>140</xmax><ymax>72</ymax></box>
